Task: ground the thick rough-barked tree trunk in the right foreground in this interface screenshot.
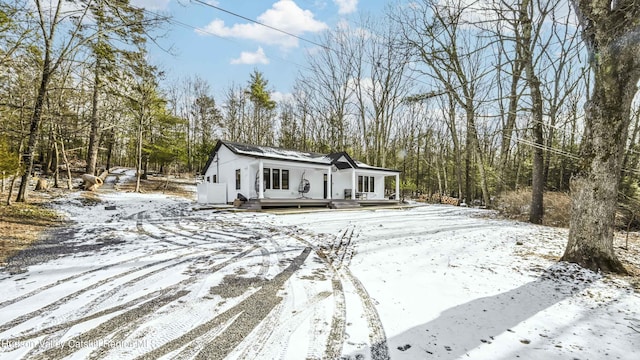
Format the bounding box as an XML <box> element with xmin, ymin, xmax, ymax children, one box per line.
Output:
<box><xmin>562</xmin><ymin>0</ymin><xmax>640</xmax><ymax>273</ymax></box>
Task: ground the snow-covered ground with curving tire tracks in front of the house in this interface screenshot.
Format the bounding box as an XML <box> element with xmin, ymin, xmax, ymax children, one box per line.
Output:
<box><xmin>0</xmin><ymin>179</ymin><xmax>640</xmax><ymax>360</ymax></box>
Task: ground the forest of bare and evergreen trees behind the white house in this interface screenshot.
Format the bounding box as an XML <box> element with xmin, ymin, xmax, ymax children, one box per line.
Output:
<box><xmin>0</xmin><ymin>0</ymin><xmax>640</xmax><ymax>217</ymax></box>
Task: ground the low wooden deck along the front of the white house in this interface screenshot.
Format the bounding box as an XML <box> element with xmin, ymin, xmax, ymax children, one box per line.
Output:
<box><xmin>240</xmin><ymin>198</ymin><xmax>400</xmax><ymax>210</ymax></box>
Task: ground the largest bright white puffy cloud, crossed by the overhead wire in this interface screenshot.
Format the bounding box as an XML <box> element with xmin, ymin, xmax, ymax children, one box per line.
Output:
<box><xmin>198</xmin><ymin>0</ymin><xmax>328</xmax><ymax>48</ymax></box>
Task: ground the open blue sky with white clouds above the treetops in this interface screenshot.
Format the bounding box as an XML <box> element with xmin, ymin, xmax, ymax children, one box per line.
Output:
<box><xmin>132</xmin><ymin>0</ymin><xmax>389</xmax><ymax>101</ymax></box>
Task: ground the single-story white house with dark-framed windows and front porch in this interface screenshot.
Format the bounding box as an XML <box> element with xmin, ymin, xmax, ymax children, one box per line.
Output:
<box><xmin>198</xmin><ymin>140</ymin><xmax>400</xmax><ymax>208</ymax></box>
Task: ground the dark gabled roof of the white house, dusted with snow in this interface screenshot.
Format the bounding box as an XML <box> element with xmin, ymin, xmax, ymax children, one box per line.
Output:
<box><xmin>203</xmin><ymin>140</ymin><xmax>400</xmax><ymax>173</ymax></box>
